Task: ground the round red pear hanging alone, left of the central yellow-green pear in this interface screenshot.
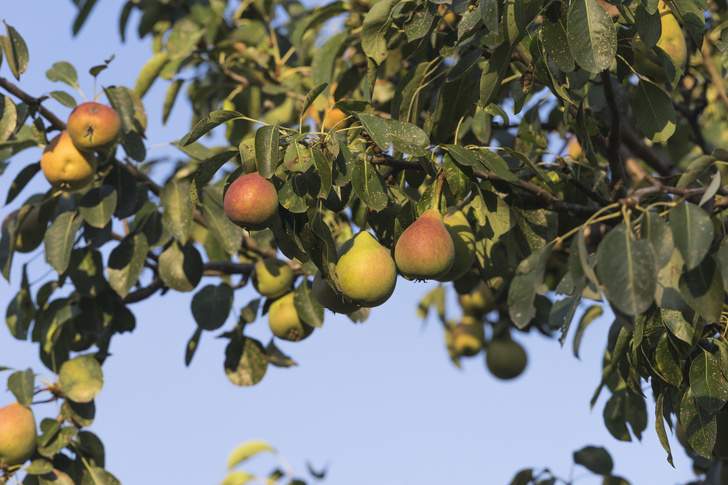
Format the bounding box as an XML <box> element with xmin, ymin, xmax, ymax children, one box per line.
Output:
<box><xmin>223</xmin><ymin>172</ymin><xmax>278</xmax><ymax>231</ymax></box>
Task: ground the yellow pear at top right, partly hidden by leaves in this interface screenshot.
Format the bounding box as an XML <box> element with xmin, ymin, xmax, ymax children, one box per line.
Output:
<box><xmin>632</xmin><ymin>6</ymin><xmax>688</xmax><ymax>83</ymax></box>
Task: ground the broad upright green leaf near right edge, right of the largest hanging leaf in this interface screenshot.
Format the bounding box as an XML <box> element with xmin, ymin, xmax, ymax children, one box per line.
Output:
<box><xmin>670</xmin><ymin>203</ymin><xmax>713</xmax><ymax>271</ymax></box>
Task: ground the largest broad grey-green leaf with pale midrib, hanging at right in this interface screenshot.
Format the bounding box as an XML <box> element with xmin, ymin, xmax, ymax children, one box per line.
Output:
<box><xmin>597</xmin><ymin>224</ymin><xmax>657</xmax><ymax>315</ymax></box>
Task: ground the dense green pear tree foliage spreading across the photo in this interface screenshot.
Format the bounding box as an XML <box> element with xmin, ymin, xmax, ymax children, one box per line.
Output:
<box><xmin>0</xmin><ymin>0</ymin><xmax>728</xmax><ymax>483</ymax></box>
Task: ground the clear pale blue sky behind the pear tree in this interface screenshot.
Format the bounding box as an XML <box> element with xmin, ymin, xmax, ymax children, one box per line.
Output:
<box><xmin>0</xmin><ymin>0</ymin><xmax>694</xmax><ymax>485</ymax></box>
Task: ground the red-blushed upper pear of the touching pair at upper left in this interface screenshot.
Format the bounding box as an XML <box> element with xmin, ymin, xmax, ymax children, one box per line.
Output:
<box><xmin>66</xmin><ymin>102</ymin><xmax>121</xmax><ymax>151</ymax></box>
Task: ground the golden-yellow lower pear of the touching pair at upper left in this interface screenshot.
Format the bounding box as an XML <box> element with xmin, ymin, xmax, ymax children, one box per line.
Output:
<box><xmin>40</xmin><ymin>130</ymin><xmax>96</xmax><ymax>191</ymax></box>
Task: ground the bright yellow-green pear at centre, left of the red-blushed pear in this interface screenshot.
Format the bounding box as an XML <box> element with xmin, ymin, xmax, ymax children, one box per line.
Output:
<box><xmin>336</xmin><ymin>231</ymin><xmax>397</xmax><ymax>307</ymax></box>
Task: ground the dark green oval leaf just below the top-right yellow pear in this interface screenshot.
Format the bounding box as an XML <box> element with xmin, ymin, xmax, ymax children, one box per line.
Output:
<box><xmin>630</xmin><ymin>79</ymin><xmax>677</xmax><ymax>143</ymax></box>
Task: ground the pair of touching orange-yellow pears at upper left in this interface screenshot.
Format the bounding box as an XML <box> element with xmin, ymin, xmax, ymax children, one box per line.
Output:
<box><xmin>40</xmin><ymin>102</ymin><xmax>121</xmax><ymax>192</ymax></box>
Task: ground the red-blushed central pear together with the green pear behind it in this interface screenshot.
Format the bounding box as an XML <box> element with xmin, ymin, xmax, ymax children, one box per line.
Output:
<box><xmin>394</xmin><ymin>207</ymin><xmax>475</xmax><ymax>282</ymax></box>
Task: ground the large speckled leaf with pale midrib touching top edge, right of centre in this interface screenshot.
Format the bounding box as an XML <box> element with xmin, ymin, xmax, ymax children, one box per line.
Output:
<box><xmin>566</xmin><ymin>0</ymin><xmax>617</xmax><ymax>74</ymax></box>
